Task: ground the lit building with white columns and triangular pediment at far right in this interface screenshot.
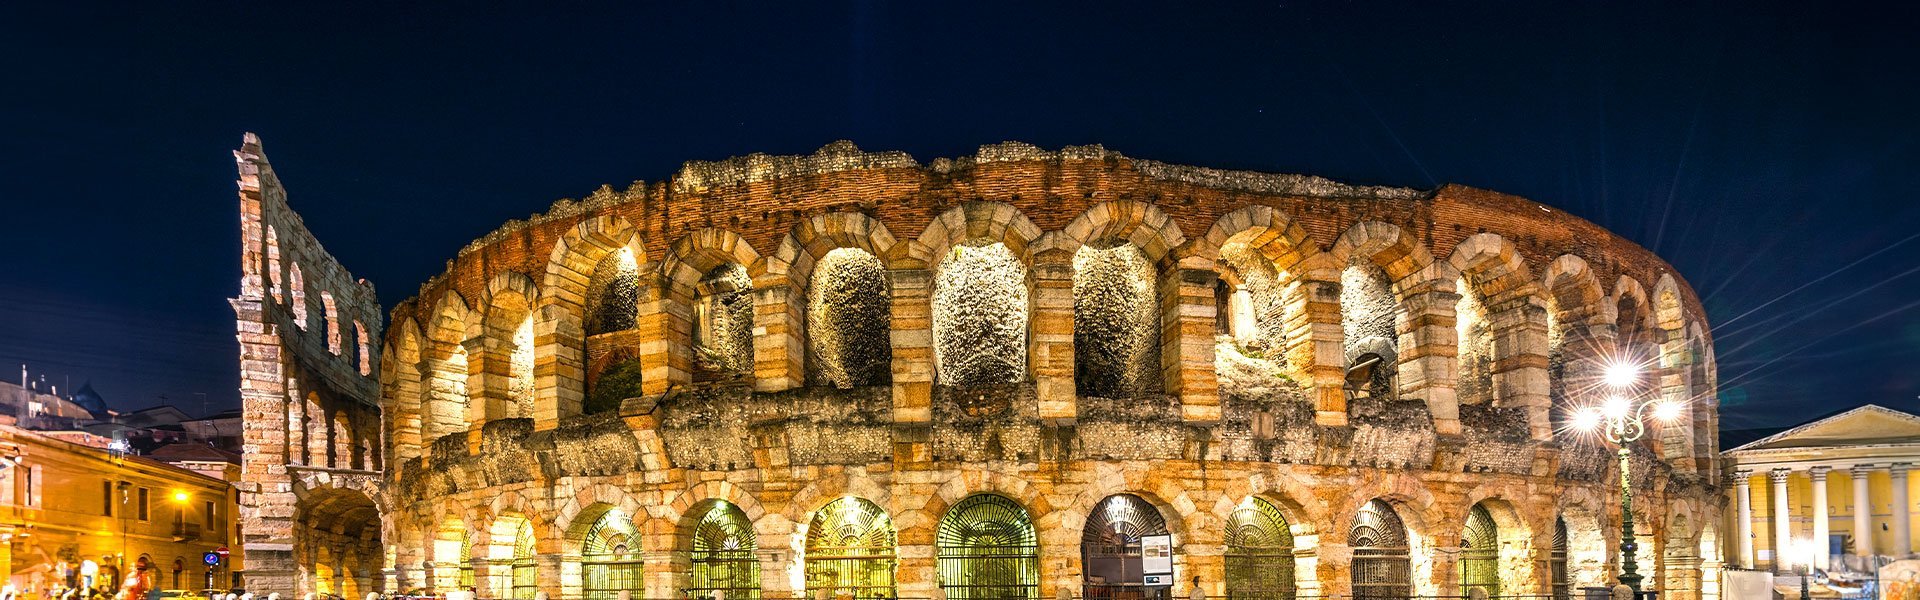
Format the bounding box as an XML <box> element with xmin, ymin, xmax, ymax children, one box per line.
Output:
<box><xmin>1724</xmin><ymin>406</ymin><xmax>1920</xmax><ymax>571</ymax></box>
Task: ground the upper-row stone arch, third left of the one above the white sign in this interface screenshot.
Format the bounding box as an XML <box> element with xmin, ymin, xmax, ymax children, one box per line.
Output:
<box><xmin>664</xmin><ymin>227</ymin><xmax>768</xmax><ymax>388</ymax></box>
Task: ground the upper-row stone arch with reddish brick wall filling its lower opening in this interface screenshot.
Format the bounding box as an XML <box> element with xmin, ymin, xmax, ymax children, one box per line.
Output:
<box><xmin>534</xmin><ymin>215</ymin><xmax>666</xmax><ymax>429</ymax></box>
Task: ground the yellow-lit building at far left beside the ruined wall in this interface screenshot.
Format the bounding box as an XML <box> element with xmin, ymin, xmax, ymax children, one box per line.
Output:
<box><xmin>0</xmin><ymin>425</ymin><xmax>240</xmax><ymax>598</ymax></box>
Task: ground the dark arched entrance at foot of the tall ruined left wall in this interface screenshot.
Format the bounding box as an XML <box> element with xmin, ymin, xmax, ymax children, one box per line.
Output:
<box><xmin>291</xmin><ymin>488</ymin><xmax>386</xmax><ymax>598</ymax></box>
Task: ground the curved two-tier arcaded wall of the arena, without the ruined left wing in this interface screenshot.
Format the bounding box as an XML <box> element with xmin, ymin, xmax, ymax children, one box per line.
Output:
<box><xmin>357</xmin><ymin>142</ymin><xmax>1720</xmax><ymax>600</ymax></box>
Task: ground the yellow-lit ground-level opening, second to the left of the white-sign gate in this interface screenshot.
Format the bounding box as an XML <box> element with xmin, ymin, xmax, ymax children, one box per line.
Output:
<box><xmin>806</xmin><ymin>496</ymin><xmax>897</xmax><ymax>598</ymax></box>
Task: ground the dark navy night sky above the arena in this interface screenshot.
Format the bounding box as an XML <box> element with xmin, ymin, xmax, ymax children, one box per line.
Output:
<box><xmin>0</xmin><ymin>2</ymin><xmax>1920</xmax><ymax>429</ymax></box>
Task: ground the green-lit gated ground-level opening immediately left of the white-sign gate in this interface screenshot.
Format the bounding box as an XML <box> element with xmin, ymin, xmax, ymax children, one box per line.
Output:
<box><xmin>937</xmin><ymin>494</ymin><xmax>1041</xmax><ymax>600</ymax></box>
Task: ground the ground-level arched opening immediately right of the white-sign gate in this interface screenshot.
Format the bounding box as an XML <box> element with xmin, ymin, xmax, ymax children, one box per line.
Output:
<box><xmin>1225</xmin><ymin>498</ymin><xmax>1298</xmax><ymax>600</ymax></box>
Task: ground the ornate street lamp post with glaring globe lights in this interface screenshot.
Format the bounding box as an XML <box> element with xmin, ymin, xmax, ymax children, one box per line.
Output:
<box><xmin>1574</xmin><ymin>363</ymin><xmax>1680</xmax><ymax>594</ymax></box>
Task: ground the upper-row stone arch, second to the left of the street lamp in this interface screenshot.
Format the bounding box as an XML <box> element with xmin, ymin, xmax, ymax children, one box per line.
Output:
<box><xmin>1448</xmin><ymin>233</ymin><xmax>1553</xmax><ymax>440</ymax></box>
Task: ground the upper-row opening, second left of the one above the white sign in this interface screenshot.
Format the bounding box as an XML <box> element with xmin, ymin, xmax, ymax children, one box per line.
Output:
<box><xmin>806</xmin><ymin>248</ymin><xmax>893</xmax><ymax>388</ymax></box>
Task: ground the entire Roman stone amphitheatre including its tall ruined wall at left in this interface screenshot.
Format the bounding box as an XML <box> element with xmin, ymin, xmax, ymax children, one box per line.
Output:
<box><xmin>234</xmin><ymin>137</ymin><xmax>1722</xmax><ymax>598</ymax></box>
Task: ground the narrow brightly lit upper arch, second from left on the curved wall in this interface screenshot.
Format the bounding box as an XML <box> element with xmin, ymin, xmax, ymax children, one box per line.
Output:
<box><xmin>420</xmin><ymin>288</ymin><xmax>472</xmax><ymax>444</ymax></box>
